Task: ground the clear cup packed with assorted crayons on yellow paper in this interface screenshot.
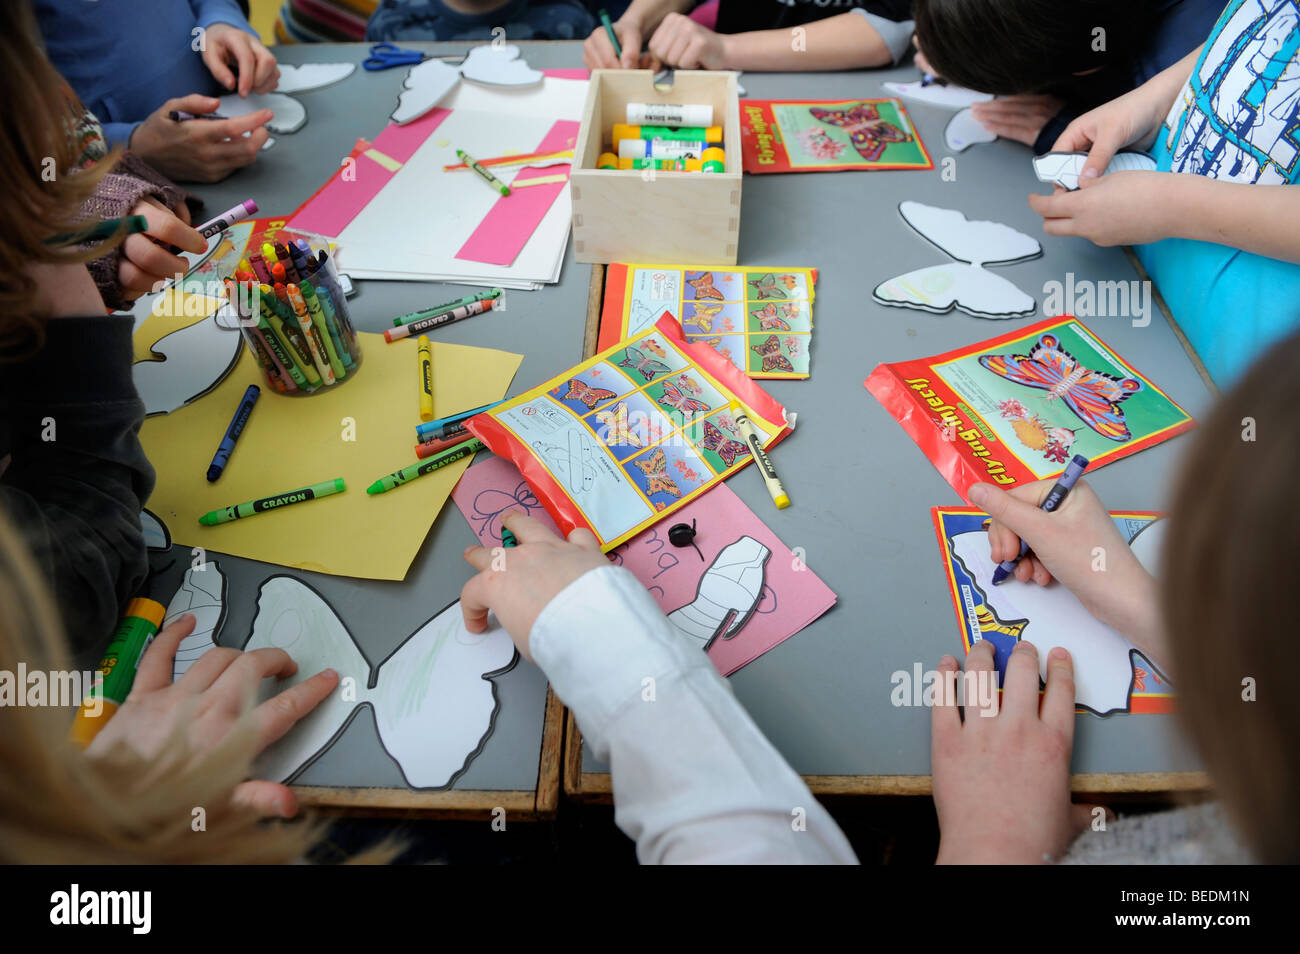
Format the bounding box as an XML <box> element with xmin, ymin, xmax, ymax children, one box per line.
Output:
<box><xmin>218</xmin><ymin>230</ymin><xmax>361</xmax><ymax>398</ymax></box>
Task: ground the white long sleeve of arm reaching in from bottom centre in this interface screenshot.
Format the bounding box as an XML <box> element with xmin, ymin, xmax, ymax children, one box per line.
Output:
<box><xmin>530</xmin><ymin>567</ymin><xmax>857</xmax><ymax>864</ymax></box>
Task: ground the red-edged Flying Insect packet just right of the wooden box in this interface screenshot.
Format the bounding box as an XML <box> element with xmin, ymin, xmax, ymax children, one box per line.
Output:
<box><xmin>740</xmin><ymin>99</ymin><xmax>935</xmax><ymax>173</ymax></box>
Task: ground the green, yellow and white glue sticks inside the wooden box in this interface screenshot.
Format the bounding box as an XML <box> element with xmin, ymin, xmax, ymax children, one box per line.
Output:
<box><xmin>595</xmin><ymin>103</ymin><xmax>727</xmax><ymax>173</ymax></box>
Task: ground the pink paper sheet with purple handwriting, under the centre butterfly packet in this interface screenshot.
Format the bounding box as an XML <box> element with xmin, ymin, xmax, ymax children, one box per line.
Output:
<box><xmin>451</xmin><ymin>458</ymin><xmax>836</xmax><ymax>676</ymax></box>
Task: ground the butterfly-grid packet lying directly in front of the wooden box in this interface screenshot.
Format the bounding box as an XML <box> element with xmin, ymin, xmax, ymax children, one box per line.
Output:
<box><xmin>599</xmin><ymin>264</ymin><xmax>816</xmax><ymax>380</ymax></box>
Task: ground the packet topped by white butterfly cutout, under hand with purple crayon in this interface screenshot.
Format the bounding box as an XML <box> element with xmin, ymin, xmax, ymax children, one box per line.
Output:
<box><xmin>931</xmin><ymin>507</ymin><xmax>1174</xmax><ymax>715</ymax></box>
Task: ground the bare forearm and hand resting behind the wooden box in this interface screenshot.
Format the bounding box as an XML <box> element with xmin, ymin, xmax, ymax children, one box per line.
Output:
<box><xmin>650</xmin><ymin>12</ymin><xmax>907</xmax><ymax>70</ymax></box>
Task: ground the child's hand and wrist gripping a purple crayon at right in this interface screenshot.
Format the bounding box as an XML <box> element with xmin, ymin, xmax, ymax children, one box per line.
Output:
<box><xmin>970</xmin><ymin>480</ymin><xmax>1160</xmax><ymax>662</ymax></box>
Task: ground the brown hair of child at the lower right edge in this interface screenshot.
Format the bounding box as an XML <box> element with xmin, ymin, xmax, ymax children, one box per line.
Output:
<box><xmin>1161</xmin><ymin>334</ymin><xmax>1300</xmax><ymax>863</ymax></box>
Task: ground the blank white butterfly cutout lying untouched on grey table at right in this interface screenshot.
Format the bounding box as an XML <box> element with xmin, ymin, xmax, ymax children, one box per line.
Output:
<box><xmin>872</xmin><ymin>201</ymin><xmax>1043</xmax><ymax>318</ymax></box>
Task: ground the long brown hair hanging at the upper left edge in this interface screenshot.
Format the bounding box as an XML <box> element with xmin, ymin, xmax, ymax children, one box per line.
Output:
<box><xmin>0</xmin><ymin>0</ymin><xmax>121</xmax><ymax>359</ymax></box>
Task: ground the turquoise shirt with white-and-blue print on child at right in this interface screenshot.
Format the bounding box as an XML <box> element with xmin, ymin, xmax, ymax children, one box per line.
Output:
<box><xmin>1135</xmin><ymin>0</ymin><xmax>1300</xmax><ymax>387</ymax></box>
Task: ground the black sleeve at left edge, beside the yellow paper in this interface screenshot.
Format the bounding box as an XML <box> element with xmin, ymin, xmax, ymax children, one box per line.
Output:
<box><xmin>0</xmin><ymin>315</ymin><xmax>153</xmax><ymax>650</ymax></box>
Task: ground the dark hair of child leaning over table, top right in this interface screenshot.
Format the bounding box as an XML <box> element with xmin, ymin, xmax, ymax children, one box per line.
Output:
<box><xmin>913</xmin><ymin>0</ymin><xmax>1156</xmax><ymax>96</ymax></box>
